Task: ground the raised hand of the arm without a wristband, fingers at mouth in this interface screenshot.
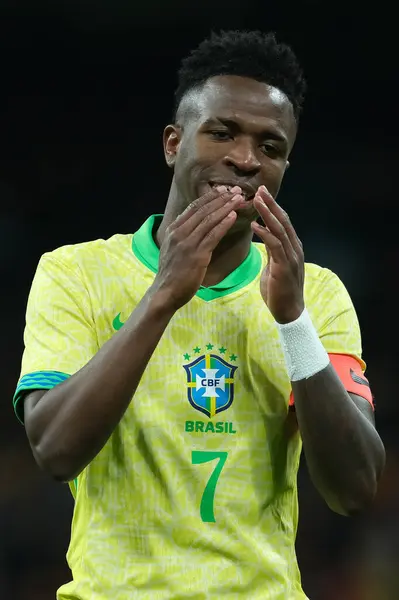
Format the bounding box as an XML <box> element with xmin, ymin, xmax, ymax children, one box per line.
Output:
<box><xmin>153</xmin><ymin>186</ymin><xmax>244</xmax><ymax>310</ymax></box>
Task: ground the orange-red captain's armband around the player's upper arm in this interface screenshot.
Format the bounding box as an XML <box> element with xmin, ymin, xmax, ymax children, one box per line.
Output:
<box><xmin>289</xmin><ymin>354</ymin><xmax>374</xmax><ymax>409</ymax></box>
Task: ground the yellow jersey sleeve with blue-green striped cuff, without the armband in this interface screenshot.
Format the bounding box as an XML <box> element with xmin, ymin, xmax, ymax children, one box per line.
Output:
<box><xmin>13</xmin><ymin>251</ymin><xmax>98</xmax><ymax>422</ymax></box>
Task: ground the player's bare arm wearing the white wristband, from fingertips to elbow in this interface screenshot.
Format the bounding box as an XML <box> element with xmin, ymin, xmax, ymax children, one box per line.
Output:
<box><xmin>253</xmin><ymin>189</ymin><xmax>385</xmax><ymax>515</ymax></box>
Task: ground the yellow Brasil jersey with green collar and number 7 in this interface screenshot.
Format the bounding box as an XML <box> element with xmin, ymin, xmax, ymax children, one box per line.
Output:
<box><xmin>14</xmin><ymin>215</ymin><xmax>365</xmax><ymax>600</ymax></box>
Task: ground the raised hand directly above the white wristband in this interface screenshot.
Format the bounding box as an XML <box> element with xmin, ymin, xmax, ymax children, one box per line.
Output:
<box><xmin>251</xmin><ymin>186</ymin><xmax>305</xmax><ymax>323</ymax></box>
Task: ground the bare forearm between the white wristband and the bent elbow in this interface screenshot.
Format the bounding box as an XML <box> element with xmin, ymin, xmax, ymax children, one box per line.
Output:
<box><xmin>293</xmin><ymin>364</ymin><xmax>385</xmax><ymax>515</ymax></box>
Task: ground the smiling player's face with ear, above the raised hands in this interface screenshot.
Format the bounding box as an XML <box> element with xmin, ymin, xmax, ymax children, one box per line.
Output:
<box><xmin>164</xmin><ymin>75</ymin><xmax>296</xmax><ymax>221</ymax></box>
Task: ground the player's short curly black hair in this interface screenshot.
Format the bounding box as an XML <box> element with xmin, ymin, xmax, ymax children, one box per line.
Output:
<box><xmin>174</xmin><ymin>31</ymin><xmax>306</xmax><ymax>120</ymax></box>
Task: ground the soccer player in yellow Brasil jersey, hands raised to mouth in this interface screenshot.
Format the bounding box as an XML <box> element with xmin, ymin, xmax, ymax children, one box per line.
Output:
<box><xmin>14</xmin><ymin>31</ymin><xmax>385</xmax><ymax>600</ymax></box>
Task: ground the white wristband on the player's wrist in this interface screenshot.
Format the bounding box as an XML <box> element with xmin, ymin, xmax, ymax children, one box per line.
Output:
<box><xmin>277</xmin><ymin>308</ymin><xmax>330</xmax><ymax>381</ymax></box>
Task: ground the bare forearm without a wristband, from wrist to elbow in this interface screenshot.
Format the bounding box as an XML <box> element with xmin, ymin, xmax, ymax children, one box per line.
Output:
<box><xmin>26</xmin><ymin>289</ymin><xmax>173</xmax><ymax>480</ymax></box>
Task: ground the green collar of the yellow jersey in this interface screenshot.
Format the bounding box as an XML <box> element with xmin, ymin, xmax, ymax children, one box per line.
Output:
<box><xmin>132</xmin><ymin>215</ymin><xmax>262</xmax><ymax>302</ymax></box>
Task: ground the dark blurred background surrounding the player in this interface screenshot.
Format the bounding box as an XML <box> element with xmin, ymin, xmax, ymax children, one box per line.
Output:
<box><xmin>0</xmin><ymin>0</ymin><xmax>399</xmax><ymax>600</ymax></box>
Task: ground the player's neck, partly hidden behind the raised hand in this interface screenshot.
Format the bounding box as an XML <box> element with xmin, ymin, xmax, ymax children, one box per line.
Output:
<box><xmin>155</xmin><ymin>183</ymin><xmax>253</xmax><ymax>287</ymax></box>
